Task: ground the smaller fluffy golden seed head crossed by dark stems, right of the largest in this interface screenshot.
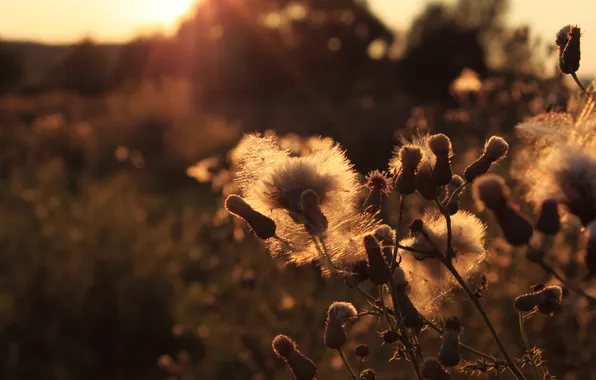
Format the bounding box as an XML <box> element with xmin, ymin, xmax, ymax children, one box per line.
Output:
<box><xmin>399</xmin><ymin>211</ymin><xmax>487</xmax><ymax>311</ymax></box>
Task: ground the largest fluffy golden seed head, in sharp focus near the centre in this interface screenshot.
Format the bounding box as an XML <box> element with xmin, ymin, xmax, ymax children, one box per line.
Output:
<box><xmin>232</xmin><ymin>135</ymin><xmax>378</xmax><ymax>267</ymax></box>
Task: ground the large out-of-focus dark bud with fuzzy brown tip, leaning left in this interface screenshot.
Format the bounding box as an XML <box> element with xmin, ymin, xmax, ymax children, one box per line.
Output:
<box><xmin>473</xmin><ymin>174</ymin><xmax>534</xmax><ymax>246</ymax></box>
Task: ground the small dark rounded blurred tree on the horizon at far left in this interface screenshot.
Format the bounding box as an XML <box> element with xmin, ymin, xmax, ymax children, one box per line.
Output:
<box><xmin>49</xmin><ymin>39</ymin><xmax>110</xmax><ymax>95</ymax></box>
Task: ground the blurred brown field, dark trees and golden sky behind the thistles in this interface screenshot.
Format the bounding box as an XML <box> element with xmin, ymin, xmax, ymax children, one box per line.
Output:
<box><xmin>0</xmin><ymin>0</ymin><xmax>596</xmax><ymax>380</ymax></box>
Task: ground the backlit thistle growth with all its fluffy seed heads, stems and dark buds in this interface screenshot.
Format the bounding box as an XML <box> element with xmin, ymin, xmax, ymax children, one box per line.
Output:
<box><xmin>187</xmin><ymin>26</ymin><xmax>596</xmax><ymax>380</ymax></box>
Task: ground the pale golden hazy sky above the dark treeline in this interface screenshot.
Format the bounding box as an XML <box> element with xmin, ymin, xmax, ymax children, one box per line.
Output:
<box><xmin>0</xmin><ymin>0</ymin><xmax>596</xmax><ymax>73</ymax></box>
